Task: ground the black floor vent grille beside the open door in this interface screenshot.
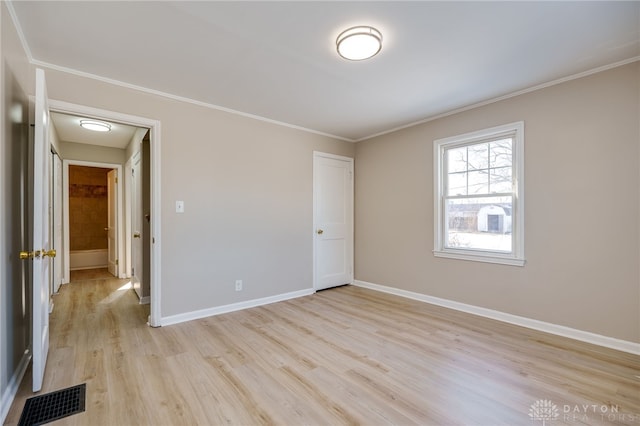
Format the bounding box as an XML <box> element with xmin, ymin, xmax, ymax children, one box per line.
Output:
<box><xmin>18</xmin><ymin>383</ymin><xmax>87</xmax><ymax>426</ymax></box>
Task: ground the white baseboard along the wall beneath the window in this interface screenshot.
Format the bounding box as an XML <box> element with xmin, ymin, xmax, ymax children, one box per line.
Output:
<box><xmin>353</xmin><ymin>280</ymin><xmax>640</xmax><ymax>355</ymax></box>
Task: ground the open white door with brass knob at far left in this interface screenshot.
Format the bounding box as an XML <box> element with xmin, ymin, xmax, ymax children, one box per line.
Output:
<box><xmin>32</xmin><ymin>69</ymin><xmax>55</xmax><ymax>392</ymax></box>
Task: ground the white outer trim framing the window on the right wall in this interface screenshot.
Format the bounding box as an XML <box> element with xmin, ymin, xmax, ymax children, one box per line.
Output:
<box><xmin>433</xmin><ymin>121</ymin><xmax>525</xmax><ymax>266</ymax></box>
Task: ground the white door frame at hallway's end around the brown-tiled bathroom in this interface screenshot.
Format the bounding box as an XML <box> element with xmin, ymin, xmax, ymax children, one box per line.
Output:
<box><xmin>62</xmin><ymin>160</ymin><xmax>127</xmax><ymax>284</ymax></box>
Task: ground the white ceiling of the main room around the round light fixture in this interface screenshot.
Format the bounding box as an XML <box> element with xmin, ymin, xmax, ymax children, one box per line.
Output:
<box><xmin>12</xmin><ymin>1</ymin><xmax>640</xmax><ymax>140</ymax></box>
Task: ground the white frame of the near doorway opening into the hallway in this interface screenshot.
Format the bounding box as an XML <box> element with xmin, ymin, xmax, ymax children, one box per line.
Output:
<box><xmin>49</xmin><ymin>99</ymin><xmax>162</xmax><ymax>327</ymax></box>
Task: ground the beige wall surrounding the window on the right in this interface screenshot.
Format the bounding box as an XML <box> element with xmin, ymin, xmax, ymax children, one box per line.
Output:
<box><xmin>355</xmin><ymin>62</ymin><xmax>640</xmax><ymax>342</ymax></box>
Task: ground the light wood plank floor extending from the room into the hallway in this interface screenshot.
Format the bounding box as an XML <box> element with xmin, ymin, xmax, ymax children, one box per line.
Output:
<box><xmin>6</xmin><ymin>276</ymin><xmax>640</xmax><ymax>426</ymax></box>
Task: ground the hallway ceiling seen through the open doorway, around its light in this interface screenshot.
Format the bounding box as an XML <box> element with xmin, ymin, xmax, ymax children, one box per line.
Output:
<box><xmin>51</xmin><ymin>112</ymin><xmax>138</xmax><ymax>149</ymax></box>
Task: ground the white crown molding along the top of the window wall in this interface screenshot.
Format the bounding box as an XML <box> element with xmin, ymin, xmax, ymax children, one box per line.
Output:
<box><xmin>353</xmin><ymin>56</ymin><xmax>640</xmax><ymax>142</ymax></box>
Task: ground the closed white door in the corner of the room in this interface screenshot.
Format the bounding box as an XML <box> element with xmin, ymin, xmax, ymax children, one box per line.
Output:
<box><xmin>313</xmin><ymin>152</ymin><xmax>353</xmax><ymax>290</ymax></box>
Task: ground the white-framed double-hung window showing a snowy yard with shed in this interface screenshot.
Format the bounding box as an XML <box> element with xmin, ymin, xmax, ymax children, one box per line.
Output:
<box><xmin>433</xmin><ymin>122</ymin><xmax>524</xmax><ymax>266</ymax></box>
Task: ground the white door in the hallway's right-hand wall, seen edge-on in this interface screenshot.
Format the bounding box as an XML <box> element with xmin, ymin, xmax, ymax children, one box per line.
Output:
<box><xmin>131</xmin><ymin>152</ymin><xmax>144</xmax><ymax>299</ymax></box>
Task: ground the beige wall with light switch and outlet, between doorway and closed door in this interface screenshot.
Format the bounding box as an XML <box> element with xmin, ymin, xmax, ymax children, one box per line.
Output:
<box><xmin>45</xmin><ymin>65</ymin><xmax>355</xmax><ymax>317</ymax></box>
